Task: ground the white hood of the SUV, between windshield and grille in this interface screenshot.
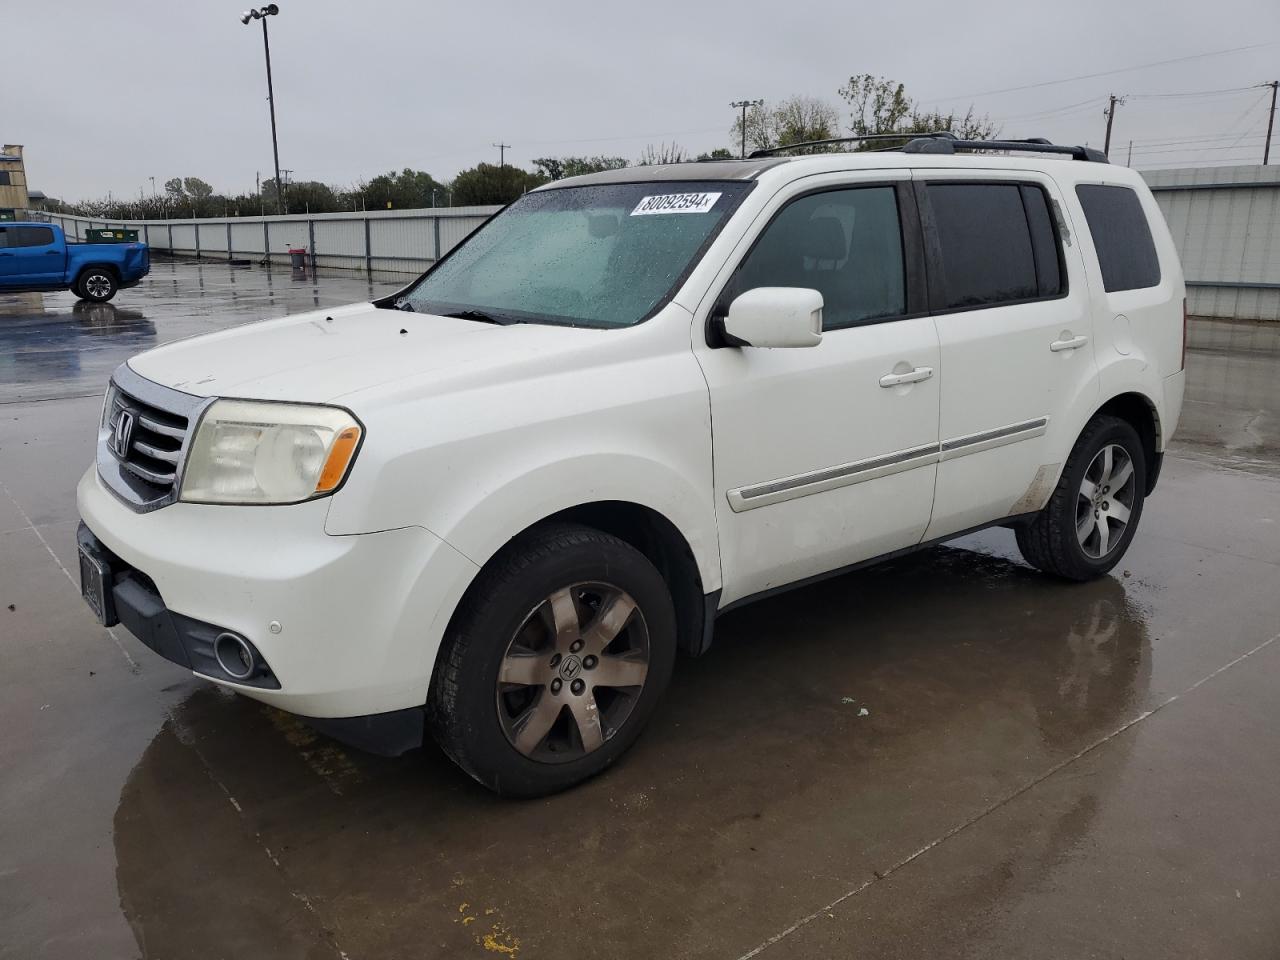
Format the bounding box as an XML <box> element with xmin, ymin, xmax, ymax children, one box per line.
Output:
<box><xmin>129</xmin><ymin>303</ymin><xmax>603</xmax><ymax>402</ymax></box>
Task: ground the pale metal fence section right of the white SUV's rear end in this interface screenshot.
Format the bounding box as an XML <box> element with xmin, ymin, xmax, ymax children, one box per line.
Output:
<box><xmin>1142</xmin><ymin>166</ymin><xmax>1280</xmax><ymax>320</ymax></box>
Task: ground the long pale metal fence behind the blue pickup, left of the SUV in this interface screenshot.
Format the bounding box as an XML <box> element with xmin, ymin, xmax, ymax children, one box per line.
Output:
<box><xmin>41</xmin><ymin>206</ymin><xmax>500</xmax><ymax>275</ymax></box>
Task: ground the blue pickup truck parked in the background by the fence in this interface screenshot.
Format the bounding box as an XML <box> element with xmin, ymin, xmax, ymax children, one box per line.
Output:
<box><xmin>0</xmin><ymin>223</ymin><xmax>151</xmax><ymax>303</ymax></box>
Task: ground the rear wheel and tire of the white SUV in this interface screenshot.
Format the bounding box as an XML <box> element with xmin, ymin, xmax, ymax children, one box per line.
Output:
<box><xmin>1016</xmin><ymin>415</ymin><xmax>1147</xmax><ymax>581</ymax></box>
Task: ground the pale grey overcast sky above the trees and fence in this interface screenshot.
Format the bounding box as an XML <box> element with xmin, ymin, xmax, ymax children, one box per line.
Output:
<box><xmin>10</xmin><ymin>0</ymin><xmax>1280</xmax><ymax>200</ymax></box>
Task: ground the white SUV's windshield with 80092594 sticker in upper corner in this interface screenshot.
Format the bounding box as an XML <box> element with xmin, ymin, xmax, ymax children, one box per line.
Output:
<box><xmin>397</xmin><ymin>180</ymin><xmax>753</xmax><ymax>328</ymax></box>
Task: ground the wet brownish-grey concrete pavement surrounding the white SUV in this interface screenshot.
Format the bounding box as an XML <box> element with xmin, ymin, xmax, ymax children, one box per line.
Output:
<box><xmin>0</xmin><ymin>262</ymin><xmax>1280</xmax><ymax>960</ymax></box>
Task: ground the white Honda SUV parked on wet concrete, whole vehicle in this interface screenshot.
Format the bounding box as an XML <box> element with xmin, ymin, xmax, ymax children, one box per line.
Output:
<box><xmin>78</xmin><ymin>137</ymin><xmax>1184</xmax><ymax>795</ymax></box>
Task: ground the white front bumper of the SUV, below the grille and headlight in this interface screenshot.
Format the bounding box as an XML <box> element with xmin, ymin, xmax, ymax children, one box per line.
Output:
<box><xmin>77</xmin><ymin>467</ymin><xmax>476</xmax><ymax>718</ymax></box>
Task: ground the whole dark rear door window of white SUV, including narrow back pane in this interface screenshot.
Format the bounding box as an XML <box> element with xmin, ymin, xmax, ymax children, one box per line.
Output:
<box><xmin>928</xmin><ymin>183</ymin><xmax>1065</xmax><ymax>310</ymax></box>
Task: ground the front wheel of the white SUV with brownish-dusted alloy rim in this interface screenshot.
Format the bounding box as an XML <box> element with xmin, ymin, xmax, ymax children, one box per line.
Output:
<box><xmin>426</xmin><ymin>525</ymin><xmax>676</xmax><ymax>797</ymax></box>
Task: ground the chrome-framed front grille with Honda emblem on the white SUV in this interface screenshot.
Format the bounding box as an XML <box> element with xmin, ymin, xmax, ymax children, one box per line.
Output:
<box><xmin>97</xmin><ymin>364</ymin><xmax>210</xmax><ymax>511</ymax></box>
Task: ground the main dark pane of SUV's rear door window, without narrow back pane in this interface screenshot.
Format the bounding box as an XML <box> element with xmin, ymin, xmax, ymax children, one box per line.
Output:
<box><xmin>929</xmin><ymin>183</ymin><xmax>1039</xmax><ymax>310</ymax></box>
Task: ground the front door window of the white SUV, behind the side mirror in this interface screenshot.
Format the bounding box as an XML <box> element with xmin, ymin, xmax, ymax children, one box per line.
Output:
<box><xmin>731</xmin><ymin>187</ymin><xmax>906</xmax><ymax>330</ymax></box>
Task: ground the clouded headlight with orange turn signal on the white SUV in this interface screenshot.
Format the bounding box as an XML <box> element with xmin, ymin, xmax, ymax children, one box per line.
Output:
<box><xmin>179</xmin><ymin>399</ymin><xmax>362</xmax><ymax>503</ymax></box>
